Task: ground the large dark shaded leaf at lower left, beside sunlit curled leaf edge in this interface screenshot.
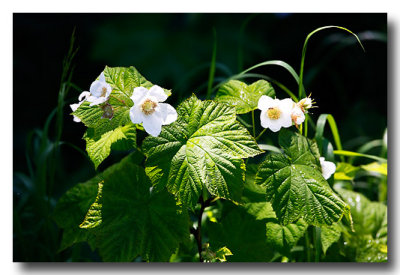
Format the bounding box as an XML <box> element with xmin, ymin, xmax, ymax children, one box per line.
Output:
<box><xmin>97</xmin><ymin>162</ymin><xmax>189</xmax><ymax>262</ymax></box>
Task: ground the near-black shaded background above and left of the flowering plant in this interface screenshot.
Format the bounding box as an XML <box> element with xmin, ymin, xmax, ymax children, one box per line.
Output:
<box><xmin>13</xmin><ymin>14</ymin><xmax>387</xmax><ymax>261</ymax></box>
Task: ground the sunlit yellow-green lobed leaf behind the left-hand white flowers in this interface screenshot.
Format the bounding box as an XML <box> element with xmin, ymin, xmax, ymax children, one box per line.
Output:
<box><xmin>72</xmin><ymin>67</ymin><xmax>171</xmax><ymax>169</ymax></box>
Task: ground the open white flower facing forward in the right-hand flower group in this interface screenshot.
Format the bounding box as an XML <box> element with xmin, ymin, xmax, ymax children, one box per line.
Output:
<box><xmin>258</xmin><ymin>95</ymin><xmax>294</xmax><ymax>132</ymax></box>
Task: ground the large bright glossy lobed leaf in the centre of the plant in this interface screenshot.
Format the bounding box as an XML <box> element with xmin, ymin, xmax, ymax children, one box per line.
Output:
<box><xmin>143</xmin><ymin>95</ymin><xmax>262</xmax><ymax>207</ymax></box>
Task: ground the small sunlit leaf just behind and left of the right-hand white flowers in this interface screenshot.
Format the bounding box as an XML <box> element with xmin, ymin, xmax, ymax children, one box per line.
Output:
<box><xmin>215</xmin><ymin>80</ymin><xmax>275</xmax><ymax>114</ymax></box>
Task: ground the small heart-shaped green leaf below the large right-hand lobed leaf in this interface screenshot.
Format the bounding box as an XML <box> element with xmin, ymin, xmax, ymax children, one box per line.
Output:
<box><xmin>266</xmin><ymin>219</ymin><xmax>308</xmax><ymax>255</ymax></box>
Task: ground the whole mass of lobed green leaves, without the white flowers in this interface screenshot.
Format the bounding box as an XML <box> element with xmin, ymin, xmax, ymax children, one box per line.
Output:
<box><xmin>54</xmin><ymin>67</ymin><xmax>387</xmax><ymax>261</ymax></box>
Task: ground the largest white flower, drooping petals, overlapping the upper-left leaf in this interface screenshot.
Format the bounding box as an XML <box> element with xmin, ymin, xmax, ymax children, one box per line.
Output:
<box><xmin>129</xmin><ymin>85</ymin><xmax>178</xmax><ymax>137</ymax></box>
